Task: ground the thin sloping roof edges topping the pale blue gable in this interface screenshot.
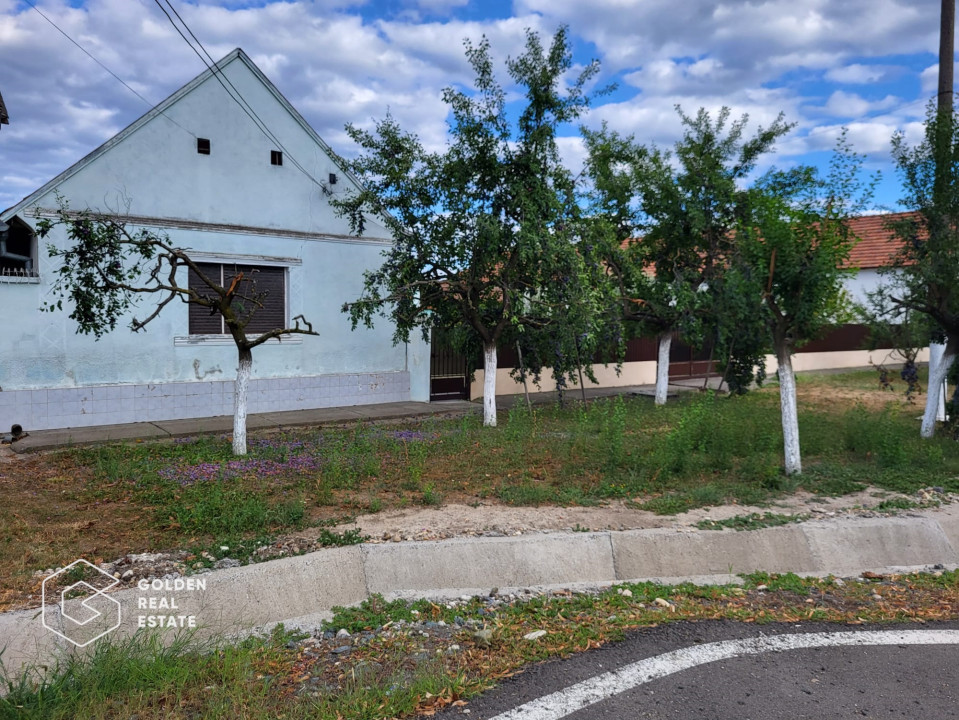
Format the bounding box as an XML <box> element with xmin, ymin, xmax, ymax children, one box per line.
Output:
<box><xmin>0</xmin><ymin>48</ymin><xmax>359</xmax><ymax>220</ymax></box>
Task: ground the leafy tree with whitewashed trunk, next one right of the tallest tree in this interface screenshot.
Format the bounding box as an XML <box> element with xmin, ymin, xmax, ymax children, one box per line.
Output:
<box><xmin>583</xmin><ymin>107</ymin><xmax>791</xmax><ymax>404</ymax></box>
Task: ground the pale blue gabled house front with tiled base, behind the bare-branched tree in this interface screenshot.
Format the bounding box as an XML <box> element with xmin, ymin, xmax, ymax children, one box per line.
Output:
<box><xmin>0</xmin><ymin>50</ymin><xmax>429</xmax><ymax>430</ymax></box>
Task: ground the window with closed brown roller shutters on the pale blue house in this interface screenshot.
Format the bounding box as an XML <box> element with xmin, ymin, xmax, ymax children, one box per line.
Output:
<box><xmin>189</xmin><ymin>263</ymin><xmax>286</xmax><ymax>335</ymax></box>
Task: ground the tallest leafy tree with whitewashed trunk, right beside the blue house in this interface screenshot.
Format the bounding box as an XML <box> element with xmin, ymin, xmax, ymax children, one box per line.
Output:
<box><xmin>334</xmin><ymin>28</ymin><xmax>599</xmax><ymax>426</ymax></box>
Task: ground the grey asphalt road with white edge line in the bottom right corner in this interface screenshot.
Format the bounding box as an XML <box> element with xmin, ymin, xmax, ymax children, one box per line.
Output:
<box><xmin>437</xmin><ymin>622</ymin><xmax>959</xmax><ymax>720</ymax></box>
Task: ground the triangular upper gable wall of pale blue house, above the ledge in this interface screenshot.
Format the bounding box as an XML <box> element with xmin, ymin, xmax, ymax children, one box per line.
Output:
<box><xmin>21</xmin><ymin>55</ymin><xmax>388</xmax><ymax>239</ymax></box>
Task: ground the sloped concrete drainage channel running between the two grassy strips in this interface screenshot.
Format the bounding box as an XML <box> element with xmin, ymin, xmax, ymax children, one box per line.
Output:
<box><xmin>0</xmin><ymin>506</ymin><xmax>959</xmax><ymax>673</ymax></box>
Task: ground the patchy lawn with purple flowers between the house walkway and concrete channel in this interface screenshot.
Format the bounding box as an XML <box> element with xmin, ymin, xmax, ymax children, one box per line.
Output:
<box><xmin>0</xmin><ymin>371</ymin><xmax>959</xmax><ymax>609</ymax></box>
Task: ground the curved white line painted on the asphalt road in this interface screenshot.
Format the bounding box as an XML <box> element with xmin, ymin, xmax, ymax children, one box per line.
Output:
<box><xmin>491</xmin><ymin>630</ymin><xmax>959</xmax><ymax>720</ymax></box>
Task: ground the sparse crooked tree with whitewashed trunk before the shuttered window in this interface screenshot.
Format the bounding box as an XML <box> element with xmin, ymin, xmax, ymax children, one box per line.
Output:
<box><xmin>37</xmin><ymin>198</ymin><xmax>319</xmax><ymax>455</ymax></box>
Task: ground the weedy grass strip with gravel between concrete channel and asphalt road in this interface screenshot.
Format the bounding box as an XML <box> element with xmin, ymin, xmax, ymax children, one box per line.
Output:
<box><xmin>0</xmin><ymin>572</ymin><xmax>959</xmax><ymax>720</ymax></box>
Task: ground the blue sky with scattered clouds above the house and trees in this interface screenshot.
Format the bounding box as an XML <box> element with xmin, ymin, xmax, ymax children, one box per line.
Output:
<box><xmin>0</xmin><ymin>0</ymin><xmax>940</xmax><ymax>210</ymax></box>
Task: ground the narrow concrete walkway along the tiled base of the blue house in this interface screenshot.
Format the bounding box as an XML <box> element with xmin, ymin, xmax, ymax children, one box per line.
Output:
<box><xmin>10</xmin><ymin>379</ymin><xmax>728</xmax><ymax>453</ymax></box>
